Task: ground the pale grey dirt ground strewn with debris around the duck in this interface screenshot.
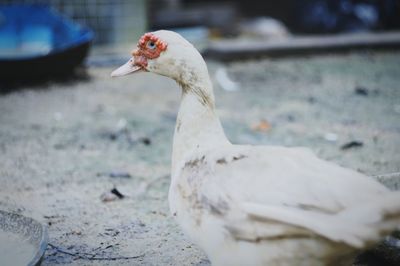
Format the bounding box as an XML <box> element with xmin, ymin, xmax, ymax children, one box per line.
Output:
<box><xmin>0</xmin><ymin>52</ymin><xmax>400</xmax><ymax>265</ymax></box>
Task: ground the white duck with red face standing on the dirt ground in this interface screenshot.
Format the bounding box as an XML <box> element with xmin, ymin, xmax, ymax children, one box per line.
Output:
<box><xmin>112</xmin><ymin>30</ymin><xmax>400</xmax><ymax>266</ymax></box>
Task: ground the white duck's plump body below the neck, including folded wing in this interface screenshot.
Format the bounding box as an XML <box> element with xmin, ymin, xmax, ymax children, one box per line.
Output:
<box><xmin>170</xmin><ymin>145</ymin><xmax>400</xmax><ymax>265</ymax></box>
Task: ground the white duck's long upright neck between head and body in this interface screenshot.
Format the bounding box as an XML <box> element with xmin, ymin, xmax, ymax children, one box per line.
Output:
<box><xmin>172</xmin><ymin>73</ymin><xmax>229</xmax><ymax>168</ymax></box>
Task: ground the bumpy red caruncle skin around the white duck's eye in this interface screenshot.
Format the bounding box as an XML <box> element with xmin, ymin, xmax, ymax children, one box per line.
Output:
<box><xmin>132</xmin><ymin>32</ymin><xmax>168</xmax><ymax>68</ymax></box>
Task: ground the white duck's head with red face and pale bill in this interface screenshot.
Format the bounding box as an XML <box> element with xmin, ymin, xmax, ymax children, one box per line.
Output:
<box><xmin>111</xmin><ymin>30</ymin><xmax>207</xmax><ymax>83</ymax></box>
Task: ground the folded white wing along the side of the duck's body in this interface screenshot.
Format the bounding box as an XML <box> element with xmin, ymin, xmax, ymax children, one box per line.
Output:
<box><xmin>180</xmin><ymin>146</ymin><xmax>400</xmax><ymax>247</ymax></box>
